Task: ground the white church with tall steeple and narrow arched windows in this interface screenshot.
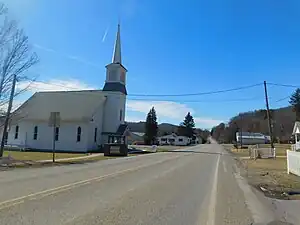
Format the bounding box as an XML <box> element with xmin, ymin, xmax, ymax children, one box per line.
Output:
<box><xmin>7</xmin><ymin>25</ymin><xmax>127</xmax><ymax>152</ymax></box>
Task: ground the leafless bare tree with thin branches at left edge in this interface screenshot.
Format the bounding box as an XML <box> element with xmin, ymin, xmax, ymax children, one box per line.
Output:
<box><xmin>0</xmin><ymin>3</ymin><xmax>38</xmax><ymax>105</ymax></box>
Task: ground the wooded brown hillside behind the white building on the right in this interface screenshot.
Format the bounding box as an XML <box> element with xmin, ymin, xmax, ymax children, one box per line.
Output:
<box><xmin>212</xmin><ymin>107</ymin><xmax>296</xmax><ymax>143</ymax></box>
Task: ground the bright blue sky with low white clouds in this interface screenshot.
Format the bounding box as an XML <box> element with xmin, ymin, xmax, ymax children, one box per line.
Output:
<box><xmin>4</xmin><ymin>0</ymin><xmax>300</xmax><ymax>128</ymax></box>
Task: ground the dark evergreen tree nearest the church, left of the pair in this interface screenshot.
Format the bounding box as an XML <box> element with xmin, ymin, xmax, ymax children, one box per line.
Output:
<box><xmin>144</xmin><ymin>107</ymin><xmax>158</xmax><ymax>145</ymax></box>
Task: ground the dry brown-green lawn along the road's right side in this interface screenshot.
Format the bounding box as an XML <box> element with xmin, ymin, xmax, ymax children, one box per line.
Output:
<box><xmin>225</xmin><ymin>144</ymin><xmax>300</xmax><ymax>199</ymax></box>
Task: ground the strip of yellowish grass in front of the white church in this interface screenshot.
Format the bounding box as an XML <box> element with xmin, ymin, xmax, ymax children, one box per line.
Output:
<box><xmin>4</xmin><ymin>151</ymin><xmax>87</xmax><ymax>161</ymax></box>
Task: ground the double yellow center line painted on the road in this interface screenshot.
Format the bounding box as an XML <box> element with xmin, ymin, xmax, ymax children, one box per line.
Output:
<box><xmin>0</xmin><ymin>155</ymin><xmax>186</xmax><ymax>210</ymax></box>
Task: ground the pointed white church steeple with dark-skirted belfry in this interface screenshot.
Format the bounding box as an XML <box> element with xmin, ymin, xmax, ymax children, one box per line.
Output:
<box><xmin>102</xmin><ymin>24</ymin><xmax>127</xmax><ymax>95</ymax></box>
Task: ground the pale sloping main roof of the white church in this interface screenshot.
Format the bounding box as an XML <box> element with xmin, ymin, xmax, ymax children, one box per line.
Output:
<box><xmin>13</xmin><ymin>90</ymin><xmax>107</xmax><ymax>121</ymax></box>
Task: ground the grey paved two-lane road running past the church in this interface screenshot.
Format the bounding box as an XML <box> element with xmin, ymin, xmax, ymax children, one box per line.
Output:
<box><xmin>0</xmin><ymin>144</ymin><xmax>276</xmax><ymax>225</ymax></box>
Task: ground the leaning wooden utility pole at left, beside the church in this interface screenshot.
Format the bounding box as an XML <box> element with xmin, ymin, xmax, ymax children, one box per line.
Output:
<box><xmin>0</xmin><ymin>74</ymin><xmax>17</xmax><ymax>158</ymax></box>
